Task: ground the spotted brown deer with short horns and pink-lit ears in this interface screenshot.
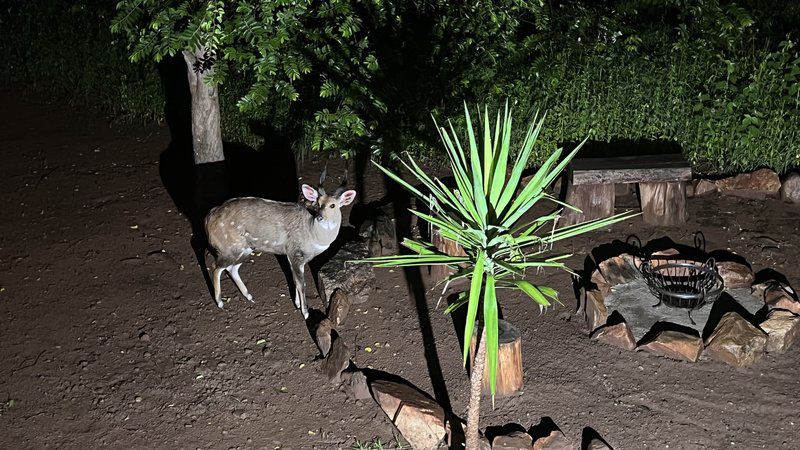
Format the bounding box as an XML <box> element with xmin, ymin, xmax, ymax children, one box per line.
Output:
<box><xmin>205</xmin><ymin>167</ymin><xmax>356</xmax><ymax>319</ymax></box>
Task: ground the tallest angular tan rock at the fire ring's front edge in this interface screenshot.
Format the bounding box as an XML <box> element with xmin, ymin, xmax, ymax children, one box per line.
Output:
<box><xmin>705</xmin><ymin>311</ymin><xmax>767</xmax><ymax>367</ymax></box>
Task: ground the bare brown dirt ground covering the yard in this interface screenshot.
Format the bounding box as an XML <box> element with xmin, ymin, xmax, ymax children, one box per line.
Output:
<box><xmin>0</xmin><ymin>89</ymin><xmax>800</xmax><ymax>449</ymax></box>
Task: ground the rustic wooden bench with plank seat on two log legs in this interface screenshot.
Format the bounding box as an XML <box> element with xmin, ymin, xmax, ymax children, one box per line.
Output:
<box><xmin>564</xmin><ymin>154</ymin><xmax>692</xmax><ymax>225</ymax></box>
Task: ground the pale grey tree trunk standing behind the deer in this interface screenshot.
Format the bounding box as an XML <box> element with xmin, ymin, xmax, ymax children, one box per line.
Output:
<box><xmin>183</xmin><ymin>48</ymin><xmax>225</xmax><ymax>164</ymax></box>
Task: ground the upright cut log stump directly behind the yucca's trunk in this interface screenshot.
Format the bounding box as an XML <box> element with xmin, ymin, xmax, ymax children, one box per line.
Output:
<box><xmin>469</xmin><ymin>319</ymin><xmax>524</xmax><ymax>397</ymax></box>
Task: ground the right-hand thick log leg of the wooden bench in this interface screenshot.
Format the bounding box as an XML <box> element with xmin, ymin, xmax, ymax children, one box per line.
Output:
<box><xmin>639</xmin><ymin>181</ymin><xmax>687</xmax><ymax>226</ymax></box>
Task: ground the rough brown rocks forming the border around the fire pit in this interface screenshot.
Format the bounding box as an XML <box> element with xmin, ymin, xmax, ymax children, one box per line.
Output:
<box><xmin>582</xmin><ymin>249</ymin><xmax>800</xmax><ymax>367</ymax></box>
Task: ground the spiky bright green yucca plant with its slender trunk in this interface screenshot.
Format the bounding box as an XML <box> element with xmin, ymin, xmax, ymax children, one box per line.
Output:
<box><xmin>368</xmin><ymin>103</ymin><xmax>632</xmax><ymax>447</ymax></box>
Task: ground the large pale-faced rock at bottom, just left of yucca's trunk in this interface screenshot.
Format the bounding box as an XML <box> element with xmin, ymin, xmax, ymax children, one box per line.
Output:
<box><xmin>370</xmin><ymin>380</ymin><xmax>447</xmax><ymax>449</ymax></box>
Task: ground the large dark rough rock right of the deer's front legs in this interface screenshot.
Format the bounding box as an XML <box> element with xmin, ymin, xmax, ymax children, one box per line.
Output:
<box><xmin>319</xmin><ymin>241</ymin><xmax>375</xmax><ymax>304</ymax></box>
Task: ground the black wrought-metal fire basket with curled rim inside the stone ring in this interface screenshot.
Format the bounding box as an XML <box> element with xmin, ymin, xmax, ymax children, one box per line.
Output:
<box><xmin>641</xmin><ymin>258</ymin><xmax>725</xmax><ymax>325</ymax></box>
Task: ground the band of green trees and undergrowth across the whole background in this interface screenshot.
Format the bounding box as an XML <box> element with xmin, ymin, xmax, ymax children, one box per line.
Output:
<box><xmin>0</xmin><ymin>0</ymin><xmax>800</xmax><ymax>174</ymax></box>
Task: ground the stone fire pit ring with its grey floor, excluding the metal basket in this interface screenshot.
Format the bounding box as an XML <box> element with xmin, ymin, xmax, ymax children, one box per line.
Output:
<box><xmin>581</xmin><ymin>249</ymin><xmax>800</xmax><ymax>367</ymax></box>
